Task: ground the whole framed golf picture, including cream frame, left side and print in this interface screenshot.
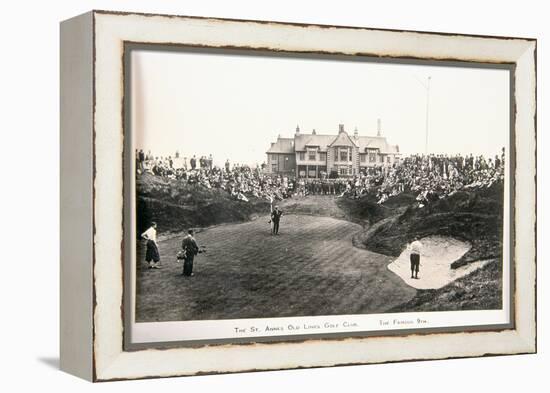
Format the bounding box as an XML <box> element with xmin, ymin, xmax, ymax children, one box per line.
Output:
<box><xmin>61</xmin><ymin>11</ymin><xmax>536</xmax><ymax>381</ymax></box>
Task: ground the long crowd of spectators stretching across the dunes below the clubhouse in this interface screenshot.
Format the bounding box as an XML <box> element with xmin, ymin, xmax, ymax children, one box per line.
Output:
<box><xmin>136</xmin><ymin>149</ymin><xmax>504</xmax><ymax>207</ymax></box>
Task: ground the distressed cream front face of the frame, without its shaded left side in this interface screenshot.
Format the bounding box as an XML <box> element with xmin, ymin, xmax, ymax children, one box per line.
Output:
<box><xmin>93</xmin><ymin>11</ymin><xmax>536</xmax><ymax>381</ymax></box>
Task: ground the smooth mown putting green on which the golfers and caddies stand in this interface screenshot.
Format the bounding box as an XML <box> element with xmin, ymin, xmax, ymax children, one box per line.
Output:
<box><xmin>136</xmin><ymin>214</ymin><xmax>417</xmax><ymax>326</ymax></box>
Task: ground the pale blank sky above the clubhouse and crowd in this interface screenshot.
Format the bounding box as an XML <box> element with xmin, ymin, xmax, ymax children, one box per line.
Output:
<box><xmin>130</xmin><ymin>50</ymin><xmax>510</xmax><ymax>164</ymax></box>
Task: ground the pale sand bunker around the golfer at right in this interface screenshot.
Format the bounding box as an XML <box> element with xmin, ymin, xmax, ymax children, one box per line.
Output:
<box><xmin>388</xmin><ymin>236</ymin><xmax>488</xmax><ymax>289</ymax></box>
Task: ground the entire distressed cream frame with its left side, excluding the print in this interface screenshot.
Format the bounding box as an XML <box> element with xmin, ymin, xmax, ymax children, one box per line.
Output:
<box><xmin>60</xmin><ymin>11</ymin><xmax>536</xmax><ymax>381</ymax></box>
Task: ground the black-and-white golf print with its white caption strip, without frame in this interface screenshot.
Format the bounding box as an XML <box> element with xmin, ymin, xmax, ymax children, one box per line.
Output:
<box><xmin>125</xmin><ymin>45</ymin><xmax>513</xmax><ymax>340</ymax></box>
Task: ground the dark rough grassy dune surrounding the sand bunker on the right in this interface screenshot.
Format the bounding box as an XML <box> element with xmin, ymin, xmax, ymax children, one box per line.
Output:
<box><xmin>340</xmin><ymin>184</ymin><xmax>504</xmax><ymax>312</ymax></box>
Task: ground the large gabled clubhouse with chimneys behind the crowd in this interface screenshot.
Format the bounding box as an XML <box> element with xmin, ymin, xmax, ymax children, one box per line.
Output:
<box><xmin>266</xmin><ymin>121</ymin><xmax>399</xmax><ymax>179</ymax></box>
